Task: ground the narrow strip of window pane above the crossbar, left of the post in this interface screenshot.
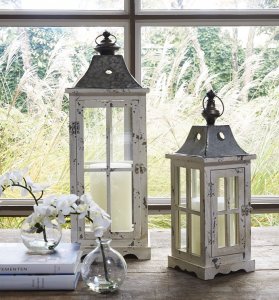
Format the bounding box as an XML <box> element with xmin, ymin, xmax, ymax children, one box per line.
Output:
<box><xmin>0</xmin><ymin>0</ymin><xmax>124</xmax><ymax>10</ymax></box>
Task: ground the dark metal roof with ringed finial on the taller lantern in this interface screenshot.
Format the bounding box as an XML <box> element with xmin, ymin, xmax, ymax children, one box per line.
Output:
<box><xmin>75</xmin><ymin>31</ymin><xmax>142</xmax><ymax>89</ymax></box>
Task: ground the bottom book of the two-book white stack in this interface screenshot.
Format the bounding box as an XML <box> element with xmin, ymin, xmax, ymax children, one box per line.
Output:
<box><xmin>0</xmin><ymin>273</ymin><xmax>80</xmax><ymax>290</ymax></box>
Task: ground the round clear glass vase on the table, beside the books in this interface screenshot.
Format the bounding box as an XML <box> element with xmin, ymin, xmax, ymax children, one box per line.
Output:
<box><xmin>81</xmin><ymin>239</ymin><xmax>127</xmax><ymax>294</ymax></box>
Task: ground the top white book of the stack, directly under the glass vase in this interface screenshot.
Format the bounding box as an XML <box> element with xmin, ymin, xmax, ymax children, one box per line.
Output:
<box><xmin>0</xmin><ymin>243</ymin><xmax>82</xmax><ymax>274</ymax></box>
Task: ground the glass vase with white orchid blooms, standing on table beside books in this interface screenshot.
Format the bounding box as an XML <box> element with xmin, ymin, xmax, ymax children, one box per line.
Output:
<box><xmin>77</xmin><ymin>195</ymin><xmax>127</xmax><ymax>294</ymax></box>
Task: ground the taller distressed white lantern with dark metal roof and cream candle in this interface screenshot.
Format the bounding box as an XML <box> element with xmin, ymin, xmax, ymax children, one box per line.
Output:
<box><xmin>66</xmin><ymin>31</ymin><xmax>150</xmax><ymax>259</ymax></box>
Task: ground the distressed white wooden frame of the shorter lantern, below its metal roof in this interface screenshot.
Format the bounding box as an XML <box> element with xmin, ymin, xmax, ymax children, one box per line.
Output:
<box><xmin>166</xmin><ymin>154</ymin><xmax>255</xmax><ymax>280</ymax></box>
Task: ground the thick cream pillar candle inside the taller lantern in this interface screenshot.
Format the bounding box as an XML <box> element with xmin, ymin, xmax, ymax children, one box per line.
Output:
<box><xmin>90</xmin><ymin>163</ymin><xmax>133</xmax><ymax>232</ymax></box>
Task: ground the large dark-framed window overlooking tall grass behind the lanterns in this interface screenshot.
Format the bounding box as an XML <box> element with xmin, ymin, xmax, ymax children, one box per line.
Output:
<box><xmin>0</xmin><ymin>0</ymin><xmax>279</xmax><ymax>216</ymax></box>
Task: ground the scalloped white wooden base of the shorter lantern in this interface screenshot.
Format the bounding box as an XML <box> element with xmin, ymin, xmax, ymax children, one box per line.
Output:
<box><xmin>168</xmin><ymin>256</ymin><xmax>255</xmax><ymax>280</ymax></box>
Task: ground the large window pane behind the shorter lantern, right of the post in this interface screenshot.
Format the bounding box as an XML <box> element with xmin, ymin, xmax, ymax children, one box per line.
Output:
<box><xmin>141</xmin><ymin>25</ymin><xmax>279</xmax><ymax>197</ymax></box>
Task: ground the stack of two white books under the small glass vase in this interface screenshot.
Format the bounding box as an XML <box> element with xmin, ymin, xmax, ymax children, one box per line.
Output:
<box><xmin>0</xmin><ymin>243</ymin><xmax>82</xmax><ymax>290</ymax></box>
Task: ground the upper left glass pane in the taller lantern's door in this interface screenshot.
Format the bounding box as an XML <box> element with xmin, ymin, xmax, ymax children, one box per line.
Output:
<box><xmin>83</xmin><ymin>108</ymin><xmax>106</xmax><ymax>167</ymax></box>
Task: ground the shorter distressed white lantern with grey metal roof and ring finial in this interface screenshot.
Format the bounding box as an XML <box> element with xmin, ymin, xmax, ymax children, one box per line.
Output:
<box><xmin>166</xmin><ymin>91</ymin><xmax>256</xmax><ymax>280</ymax></box>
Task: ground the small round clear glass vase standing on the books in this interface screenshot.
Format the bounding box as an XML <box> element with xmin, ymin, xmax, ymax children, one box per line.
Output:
<box><xmin>20</xmin><ymin>215</ymin><xmax>62</xmax><ymax>254</ymax></box>
